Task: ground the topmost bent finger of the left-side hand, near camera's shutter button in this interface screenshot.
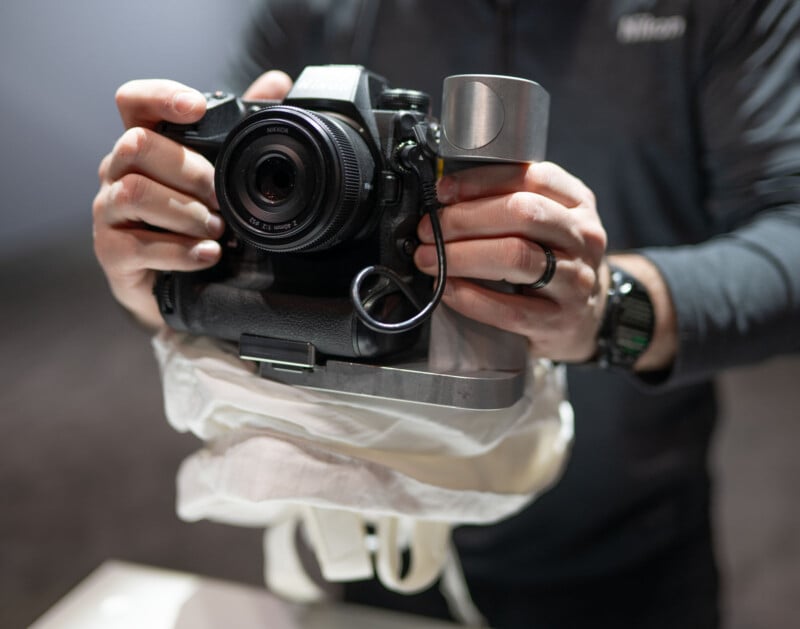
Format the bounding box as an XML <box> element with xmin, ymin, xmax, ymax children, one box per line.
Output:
<box><xmin>116</xmin><ymin>79</ymin><xmax>206</xmax><ymax>129</ymax></box>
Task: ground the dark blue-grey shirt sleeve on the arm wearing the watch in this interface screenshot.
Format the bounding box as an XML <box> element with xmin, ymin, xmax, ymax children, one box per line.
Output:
<box><xmin>640</xmin><ymin>0</ymin><xmax>800</xmax><ymax>385</ymax></box>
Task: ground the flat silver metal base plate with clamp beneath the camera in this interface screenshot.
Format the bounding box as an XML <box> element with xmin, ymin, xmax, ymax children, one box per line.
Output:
<box><xmin>239</xmin><ymin>334</ymin><xmax>525</xmax><ymax>410</ymax></box>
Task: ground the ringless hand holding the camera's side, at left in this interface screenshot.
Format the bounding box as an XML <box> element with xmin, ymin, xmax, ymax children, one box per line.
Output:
<box><xmin>92</xmin><ymin>71</ymin><xmax>292</xmax><ymax>329</ymax></box>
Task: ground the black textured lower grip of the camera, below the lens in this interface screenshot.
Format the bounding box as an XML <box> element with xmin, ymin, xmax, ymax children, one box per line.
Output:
<box><xmin>155</xmin><ymin>273</ymin><xmax>418</xmax><ymax>358</ymax></box>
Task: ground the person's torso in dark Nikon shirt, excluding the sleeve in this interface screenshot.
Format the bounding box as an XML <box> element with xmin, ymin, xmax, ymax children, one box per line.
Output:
<box><xmin>242</xmin><ymin>0</ymin><xmax>716</xmax><ymax>581</ymax></box>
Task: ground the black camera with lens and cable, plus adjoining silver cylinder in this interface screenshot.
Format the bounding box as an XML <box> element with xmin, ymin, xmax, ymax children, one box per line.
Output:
<box><xmin>154</xmin><ymin>65</ymin><xmax>548</xmax><ymax>408</ymax></box>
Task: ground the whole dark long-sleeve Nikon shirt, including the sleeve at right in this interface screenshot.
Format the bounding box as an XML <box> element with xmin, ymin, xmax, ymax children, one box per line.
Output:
<box><xmin>231</xmin><ymin>0</ymin><xmax>800</xmax><ymax>600</ymax></box>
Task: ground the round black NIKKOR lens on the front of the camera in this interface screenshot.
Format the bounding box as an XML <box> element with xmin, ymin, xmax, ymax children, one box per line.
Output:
<box><xmin>216</xmin><ymin>105</ymin><xmax>375</xmax><ymax>252</ymax></box>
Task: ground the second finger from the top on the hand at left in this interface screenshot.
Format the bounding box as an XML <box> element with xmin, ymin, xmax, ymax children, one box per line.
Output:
<box><xmin>99</xmin><ymin>127</ymin><xmax>217</xmax><ymax>208</ymax></box>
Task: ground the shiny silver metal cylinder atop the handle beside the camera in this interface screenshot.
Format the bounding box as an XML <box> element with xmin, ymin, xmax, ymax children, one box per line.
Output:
<box><xmin>439</xmin><ymin>74</ymin><xmax>550</xmax><ymax>162</ymax></box>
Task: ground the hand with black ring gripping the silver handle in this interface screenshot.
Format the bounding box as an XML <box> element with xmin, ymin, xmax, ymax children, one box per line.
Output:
<box><xmin>414</xmin><ymin>162</ymin><xmax>609</xmax><ymax>362</ymax></box>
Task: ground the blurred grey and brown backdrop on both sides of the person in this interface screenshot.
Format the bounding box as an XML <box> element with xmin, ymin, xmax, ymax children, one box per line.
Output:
<box><xmin>0</xmin><ymin>0</ymin><xmax>800</xmax><ymax>629</ymax></box>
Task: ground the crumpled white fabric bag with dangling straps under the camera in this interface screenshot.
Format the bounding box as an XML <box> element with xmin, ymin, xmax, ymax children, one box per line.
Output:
<box><xmin>153</xmin><ymin>306</ymin><xmax>573</xmax><ymax>612</ymax></box>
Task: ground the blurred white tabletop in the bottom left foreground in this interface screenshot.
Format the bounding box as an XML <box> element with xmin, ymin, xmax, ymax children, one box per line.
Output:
<box><xmin>30</xmin><ymin>560</ymin><xmax>457</xmax><ymax>629</ymax></box>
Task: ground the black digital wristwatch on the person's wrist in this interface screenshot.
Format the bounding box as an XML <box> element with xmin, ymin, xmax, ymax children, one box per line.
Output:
<box><xmin>593</xmin><ymin>264</ymin><xmax>655</xmax><ymax>371</ymax></box>
